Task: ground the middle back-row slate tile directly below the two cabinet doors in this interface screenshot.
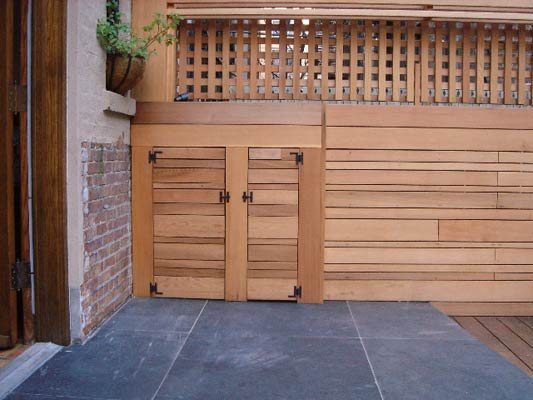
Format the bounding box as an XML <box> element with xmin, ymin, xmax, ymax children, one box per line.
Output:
<box><xmin>194</xmin><ymin>301</ymin><xmax>357</xmax><ymax>337</ymax></box>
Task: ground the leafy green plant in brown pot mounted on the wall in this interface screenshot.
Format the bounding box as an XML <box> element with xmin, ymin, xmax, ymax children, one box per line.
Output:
<box><xmin>96</xmin><ymin>0</ymin><xmax>181</xmax><ymax>94</ymax></box>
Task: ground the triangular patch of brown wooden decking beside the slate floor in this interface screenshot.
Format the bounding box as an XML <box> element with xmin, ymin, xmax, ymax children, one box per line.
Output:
<box><xmin>455</xmin><ymin>317</ymin><xmax>533</xmax><ymax>377</ymax></box>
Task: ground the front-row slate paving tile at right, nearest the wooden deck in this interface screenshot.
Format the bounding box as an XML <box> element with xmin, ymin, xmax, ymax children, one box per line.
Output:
<box><xmin>364</xmin><ymin>339</ymin><xmax>533</xmax><ymax>400</ymax></box>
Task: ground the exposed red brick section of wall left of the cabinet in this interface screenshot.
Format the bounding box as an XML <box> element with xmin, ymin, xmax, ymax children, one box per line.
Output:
<box><xmin>80</xmin><ymin>139</ymin><xmax>132</xmax><ymax>335</ymax></box>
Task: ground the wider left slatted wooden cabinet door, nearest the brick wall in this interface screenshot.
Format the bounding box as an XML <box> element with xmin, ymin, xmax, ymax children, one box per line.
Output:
<box><xmin>152</xmin><ymin>148</ymin><xmax>225</xmax><ymax>299</ymax></box>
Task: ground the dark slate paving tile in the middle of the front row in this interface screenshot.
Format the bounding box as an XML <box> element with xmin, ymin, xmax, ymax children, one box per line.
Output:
<box><xmin>158</xmin><ymin>335</ymin><xmax>380</xmax><ymax>400</ymax></box>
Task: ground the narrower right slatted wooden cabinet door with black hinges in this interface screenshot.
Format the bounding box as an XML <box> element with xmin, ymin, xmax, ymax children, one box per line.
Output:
<box><xmin>247</xmin><ymin>148</ymin><xmax>299</xmax><ymax>300</ymax></box>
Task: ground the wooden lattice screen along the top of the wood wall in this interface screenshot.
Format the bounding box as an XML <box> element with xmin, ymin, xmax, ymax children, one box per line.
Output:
<box><xmin>176</xmin><ymin>19</ymin><xmax>533</xmax><ymax>104</ymax></box>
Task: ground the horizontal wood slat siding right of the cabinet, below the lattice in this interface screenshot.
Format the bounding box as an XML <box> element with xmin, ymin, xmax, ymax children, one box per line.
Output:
<box><xmin>324</xmin><ymin>105</ymin><xmax>533</xmax><ymax>304</ymax></box>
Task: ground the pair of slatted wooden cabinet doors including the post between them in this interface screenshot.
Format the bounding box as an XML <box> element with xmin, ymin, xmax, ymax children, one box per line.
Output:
<box><xmin>140</xmin><ymin>147</ymin><xmax>322</xmax><ymax>302</ymax></box>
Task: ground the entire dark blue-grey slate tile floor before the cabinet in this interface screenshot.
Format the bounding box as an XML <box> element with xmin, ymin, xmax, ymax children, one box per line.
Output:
<box><xmin>4</xmin><ymin>299</ymin><xmax>533</xmax><ymax>400</ymax></box>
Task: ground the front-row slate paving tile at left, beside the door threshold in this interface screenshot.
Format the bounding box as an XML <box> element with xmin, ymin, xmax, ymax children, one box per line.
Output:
<box><xmin>9</xmin><ymin>330</ymin><xmax>185</xmax><ymax>400</ymax></box>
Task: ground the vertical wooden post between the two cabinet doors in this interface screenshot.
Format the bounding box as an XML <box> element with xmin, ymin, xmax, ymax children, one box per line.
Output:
<box><xmin>224</xmin><ymin>147</ymin><xmax>248</xmax><ymax>301</ymax></box>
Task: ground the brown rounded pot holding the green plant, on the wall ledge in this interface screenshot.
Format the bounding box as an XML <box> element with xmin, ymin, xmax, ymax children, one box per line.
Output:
<box><xmin>106</xmin><ymin>54</ymin><xmax>146</xmax><ymax>95</ymax></box>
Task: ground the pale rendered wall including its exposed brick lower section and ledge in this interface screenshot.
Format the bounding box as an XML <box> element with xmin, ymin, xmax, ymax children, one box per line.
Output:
<box><xmin>67</xmin><ymin>0</ymin><xmax>135</xmax><ymax>341</ymax></box>
